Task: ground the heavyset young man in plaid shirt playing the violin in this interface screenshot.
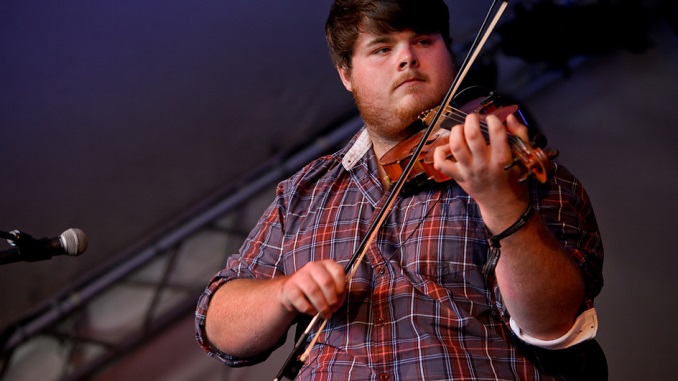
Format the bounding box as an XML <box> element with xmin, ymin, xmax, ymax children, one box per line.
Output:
<box><xmin>196</xmin><ymin>0</ymin><xmax>603</xmax><ymax>380</ymax></box>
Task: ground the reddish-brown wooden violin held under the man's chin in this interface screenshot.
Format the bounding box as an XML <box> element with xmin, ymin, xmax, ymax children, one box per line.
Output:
<box><xmin>379</xmin><ymin>88</ymin><xmax>558</xmax><ymax>190</ymax></box>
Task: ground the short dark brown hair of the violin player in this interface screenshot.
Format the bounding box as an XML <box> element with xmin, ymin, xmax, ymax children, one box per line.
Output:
<box><xmin>325</xmin><ymin>0</ymin><xmax>452</xmax><ymax>69</ymax></box>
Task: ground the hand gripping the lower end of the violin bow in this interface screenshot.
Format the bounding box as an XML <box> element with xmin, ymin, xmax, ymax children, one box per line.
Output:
<box><xmin>280</xmin><ymin>259</ymin><xmax>346</xmax><ymax>319</ymax></box>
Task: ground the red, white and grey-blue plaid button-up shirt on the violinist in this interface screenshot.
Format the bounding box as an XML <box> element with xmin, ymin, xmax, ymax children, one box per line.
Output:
<box><xmin>196</xmin><ymin>130</ymin><xmax>603</xmax><ymax>381</ymax></box>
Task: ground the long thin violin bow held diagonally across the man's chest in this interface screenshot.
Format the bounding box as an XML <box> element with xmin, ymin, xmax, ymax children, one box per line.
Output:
<box><xmin>273</xmin><ymin>0</ymin><xmax>508</xmax><ymax>381</ymax></box>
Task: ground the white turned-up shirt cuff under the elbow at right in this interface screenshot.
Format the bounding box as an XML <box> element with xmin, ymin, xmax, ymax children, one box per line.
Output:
<box><xmin>509</xmin><ymin>308</ymin><xmax>598</xmax><ymax>350</ymax></box>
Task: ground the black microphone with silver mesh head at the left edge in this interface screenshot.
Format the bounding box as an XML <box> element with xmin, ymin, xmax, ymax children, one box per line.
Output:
<box><xmin>0</xmin><ymin>229</ymin><xmax>87</xmax><ymax>264</ymax></box>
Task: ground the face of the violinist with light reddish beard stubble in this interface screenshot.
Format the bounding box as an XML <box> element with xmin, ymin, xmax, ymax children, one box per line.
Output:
<box><xmin>338</xmin><ymin>30</ymin><xmax>454</xmax><ymax>146</ymax></box>
